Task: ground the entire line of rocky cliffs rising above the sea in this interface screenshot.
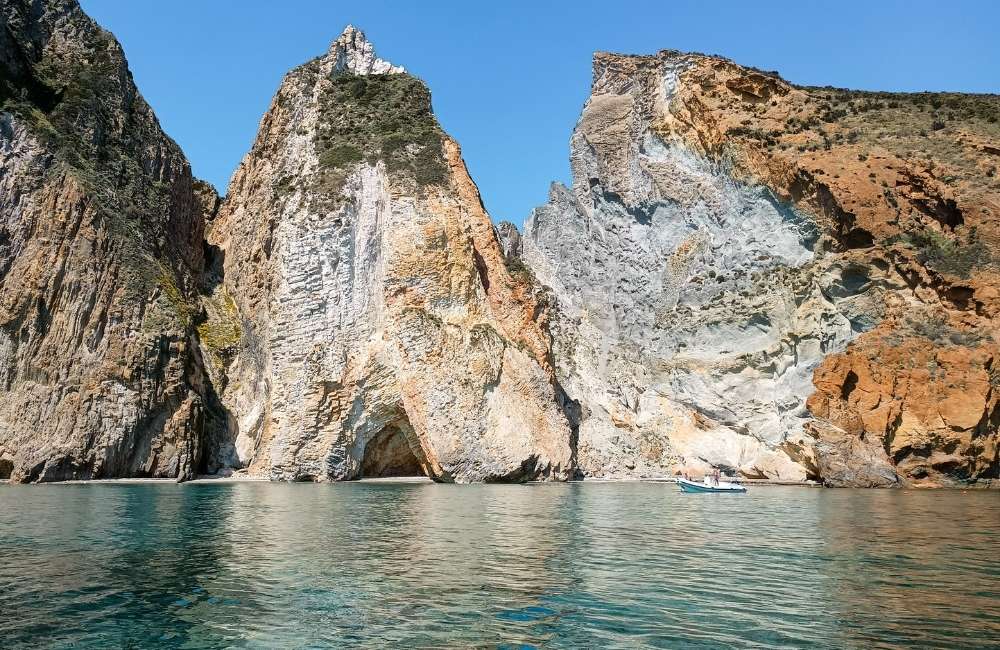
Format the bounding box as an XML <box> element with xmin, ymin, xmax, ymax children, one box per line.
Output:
<box><xmin>0</xmin><ymin>0</ymin><xmax>1000</xmax><ymax>486</ymax></box>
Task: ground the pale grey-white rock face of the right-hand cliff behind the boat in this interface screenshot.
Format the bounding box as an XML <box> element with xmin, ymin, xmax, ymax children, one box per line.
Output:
<box><xmin>522</xmin><ymin>59</ymin><xmax>872</xmax><ymax>479</ymax></box>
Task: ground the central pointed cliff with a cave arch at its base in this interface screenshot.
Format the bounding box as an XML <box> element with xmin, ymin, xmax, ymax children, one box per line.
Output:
<box><xmin>200</xmin><ymin>27</ymin><xmax>571</xmax><ymax>482</ymax></box>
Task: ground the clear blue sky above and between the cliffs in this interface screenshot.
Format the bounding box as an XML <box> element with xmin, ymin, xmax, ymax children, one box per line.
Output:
<box><xmin>81</xmin><ymin>0</ymin><xmax>1000</xmax><ymax>224</ymax></box>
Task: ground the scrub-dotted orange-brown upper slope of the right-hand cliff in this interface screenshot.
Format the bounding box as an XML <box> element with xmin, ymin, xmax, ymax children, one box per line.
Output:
<box><xmin>699</xmin><ymin>61</ymin><xmax>1000</xmax><ymax>279</ymax></box>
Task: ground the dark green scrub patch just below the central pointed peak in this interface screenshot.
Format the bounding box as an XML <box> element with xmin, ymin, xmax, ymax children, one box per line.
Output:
<box><xmin>315</xmin><ymin>74</ymin><xmax>447</xmax><ymax>191</ymax></box>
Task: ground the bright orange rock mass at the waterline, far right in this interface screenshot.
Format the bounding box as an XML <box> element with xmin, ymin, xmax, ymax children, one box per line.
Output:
<box><xmin>809</xmin><ymin>328</ymin><xmax>1000</xmax><ymax>486</ymax></box>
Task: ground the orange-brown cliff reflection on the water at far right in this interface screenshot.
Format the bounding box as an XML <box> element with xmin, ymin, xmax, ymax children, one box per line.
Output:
<box><xmin>821</xmin><ymin>491</ymin><xmax>1000</xmax><ymax>648</ymax></box>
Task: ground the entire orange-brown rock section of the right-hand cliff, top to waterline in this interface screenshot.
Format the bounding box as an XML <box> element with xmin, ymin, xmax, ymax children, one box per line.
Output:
<box><xmin>648</xmin><ymin>55</ymin><xmax>1000</xmax><ymax>485</ymax></box>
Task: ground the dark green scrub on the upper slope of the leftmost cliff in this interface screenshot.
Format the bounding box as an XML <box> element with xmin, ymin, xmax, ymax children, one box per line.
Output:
<box><xmin>0</xmin><ymin>25</ymin><xmax>189</xmax><ymax>321</ymax></box>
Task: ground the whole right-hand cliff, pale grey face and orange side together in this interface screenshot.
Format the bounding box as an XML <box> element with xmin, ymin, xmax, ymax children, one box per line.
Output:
<box><xmin>520</xmin><ymin>51</ymin><xmax>1000</xmax><ymax>485</ymax></box>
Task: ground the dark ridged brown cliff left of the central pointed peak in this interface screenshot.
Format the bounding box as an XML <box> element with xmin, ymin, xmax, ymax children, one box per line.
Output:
<box><xmin>0</xmin><ymin>0</ymin><xmax>216</xmax><ymax>481</ymax></box>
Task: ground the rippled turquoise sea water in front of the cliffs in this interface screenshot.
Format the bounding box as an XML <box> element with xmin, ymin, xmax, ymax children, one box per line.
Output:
<box><xmin>0</xmin><ymin>483</ymin><xmax>1000</xmax><ymax>648</ymax></box>
